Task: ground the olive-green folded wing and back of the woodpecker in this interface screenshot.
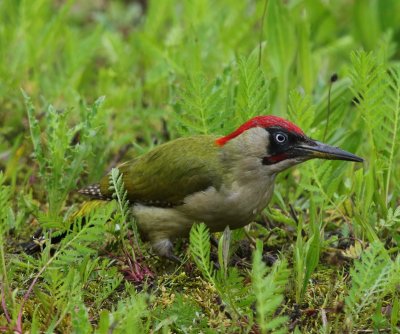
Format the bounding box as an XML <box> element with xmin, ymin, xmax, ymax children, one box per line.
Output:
<box><xmin>100</xmin><ymin>136</ymin><xmax>222</xmax><ymax>207</ymax></box>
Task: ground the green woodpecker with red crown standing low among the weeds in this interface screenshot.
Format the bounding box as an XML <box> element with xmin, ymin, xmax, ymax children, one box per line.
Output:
<box><xmin>78</xmin><ymin>115</ymin><xmax>363</xmax><ymax>261</ymax></box>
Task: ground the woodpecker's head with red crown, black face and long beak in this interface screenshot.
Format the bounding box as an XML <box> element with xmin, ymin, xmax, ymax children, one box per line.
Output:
<box><xmin>216</xmin><ymin>116</ymin><xmax>363</xmax><ymax>173</ymax></box>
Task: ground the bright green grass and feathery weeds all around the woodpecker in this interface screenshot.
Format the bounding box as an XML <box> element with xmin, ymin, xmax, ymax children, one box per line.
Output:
<box><xmin>0</xmin><ymin>0</ymin><xmax>400</xmax><ymax>333</ymax></box>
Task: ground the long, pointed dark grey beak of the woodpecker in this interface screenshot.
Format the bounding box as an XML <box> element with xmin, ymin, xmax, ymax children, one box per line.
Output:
<box><xmin>296</xmin><ymin>141</ymin><xmax>364</xmax><ymax>162</ymax></box>
